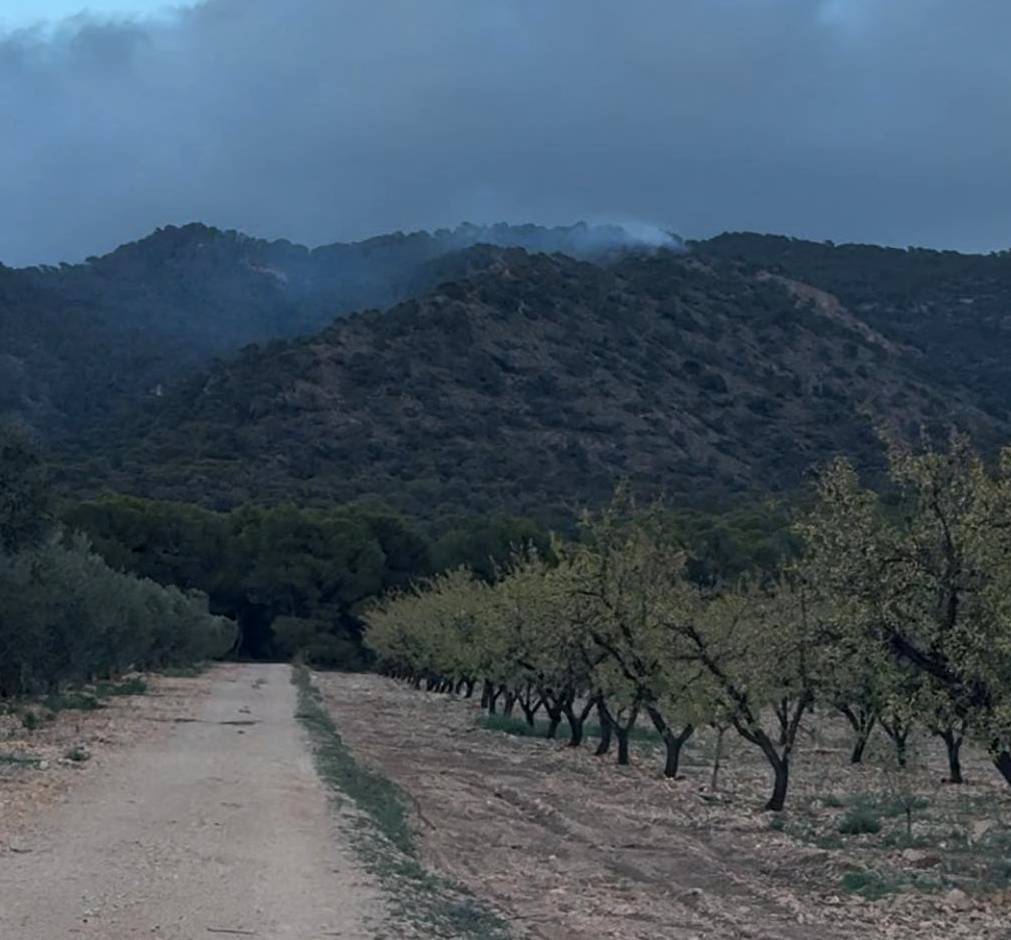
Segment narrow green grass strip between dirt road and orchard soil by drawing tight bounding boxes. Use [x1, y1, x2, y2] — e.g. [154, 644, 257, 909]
[291, 666, 510, 940]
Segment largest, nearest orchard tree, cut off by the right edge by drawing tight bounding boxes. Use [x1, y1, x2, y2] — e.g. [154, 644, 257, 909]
[801, 437, 1011, 784]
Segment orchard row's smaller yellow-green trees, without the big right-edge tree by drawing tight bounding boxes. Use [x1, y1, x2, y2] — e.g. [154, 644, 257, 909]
[365, 489, 830, 810]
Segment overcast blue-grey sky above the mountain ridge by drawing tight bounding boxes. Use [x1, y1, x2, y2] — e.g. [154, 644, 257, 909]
[0, 0, 1011, 265]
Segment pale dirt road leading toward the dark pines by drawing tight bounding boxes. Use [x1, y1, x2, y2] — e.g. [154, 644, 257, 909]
[0, 665, 383, 940]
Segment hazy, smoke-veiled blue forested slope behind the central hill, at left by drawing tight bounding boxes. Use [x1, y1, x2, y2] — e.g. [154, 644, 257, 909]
[0, 224, 655, 439]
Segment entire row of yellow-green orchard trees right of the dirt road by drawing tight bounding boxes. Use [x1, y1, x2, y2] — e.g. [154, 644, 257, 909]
[366, 439, 1011, 811]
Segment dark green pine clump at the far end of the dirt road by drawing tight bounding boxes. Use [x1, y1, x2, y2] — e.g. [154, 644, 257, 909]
[64, 495, 431, 668]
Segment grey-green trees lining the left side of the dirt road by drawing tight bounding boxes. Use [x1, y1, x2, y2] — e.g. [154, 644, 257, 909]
[0, 429, 235, 698]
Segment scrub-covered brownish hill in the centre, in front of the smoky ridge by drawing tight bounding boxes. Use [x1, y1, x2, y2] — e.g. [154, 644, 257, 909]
[70, 248, 1006, 523]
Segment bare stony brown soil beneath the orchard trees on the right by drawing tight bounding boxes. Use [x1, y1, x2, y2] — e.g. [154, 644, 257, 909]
[317, 675, 1011, 940]
